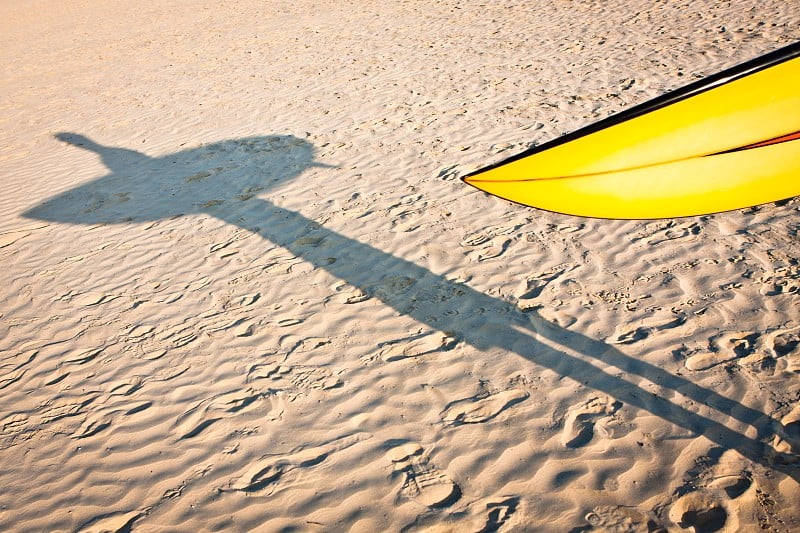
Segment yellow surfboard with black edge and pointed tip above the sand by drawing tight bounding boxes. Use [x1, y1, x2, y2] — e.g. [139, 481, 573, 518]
[463, 43, 800, 219]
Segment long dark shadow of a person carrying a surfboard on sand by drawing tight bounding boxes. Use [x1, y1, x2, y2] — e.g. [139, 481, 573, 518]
[24, 133, 797, 479]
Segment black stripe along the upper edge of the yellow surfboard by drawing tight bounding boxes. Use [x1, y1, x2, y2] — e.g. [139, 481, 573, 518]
[461, 42, 800, 179]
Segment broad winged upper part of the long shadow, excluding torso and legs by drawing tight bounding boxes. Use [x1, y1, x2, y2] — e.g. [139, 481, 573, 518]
[23, 132, 326, 224]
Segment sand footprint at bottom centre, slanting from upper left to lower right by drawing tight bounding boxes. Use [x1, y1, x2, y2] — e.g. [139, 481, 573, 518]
[387, 442, 461, 508]
